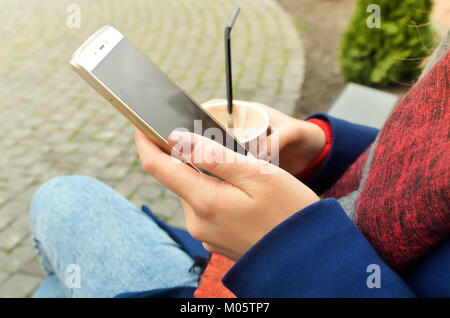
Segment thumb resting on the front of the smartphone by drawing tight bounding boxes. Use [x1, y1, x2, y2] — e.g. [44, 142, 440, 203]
[169, 131, 262, 188]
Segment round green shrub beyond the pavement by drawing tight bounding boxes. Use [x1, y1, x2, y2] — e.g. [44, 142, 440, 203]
[339, 0, 434, 85]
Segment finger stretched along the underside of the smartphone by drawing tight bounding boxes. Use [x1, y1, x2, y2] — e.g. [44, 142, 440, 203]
[135, 129, 225, 203]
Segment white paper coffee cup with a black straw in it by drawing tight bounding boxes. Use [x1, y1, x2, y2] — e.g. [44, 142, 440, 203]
[202, 101, 269, 147]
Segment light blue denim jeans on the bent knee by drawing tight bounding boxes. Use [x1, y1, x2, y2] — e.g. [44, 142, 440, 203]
[30, 176, 199, 297]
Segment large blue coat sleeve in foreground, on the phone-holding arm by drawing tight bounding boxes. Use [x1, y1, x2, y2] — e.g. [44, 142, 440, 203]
[223, 199, 415, 297]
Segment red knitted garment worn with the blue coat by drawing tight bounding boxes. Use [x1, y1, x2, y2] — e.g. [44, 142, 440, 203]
[194, 52, 450, 297]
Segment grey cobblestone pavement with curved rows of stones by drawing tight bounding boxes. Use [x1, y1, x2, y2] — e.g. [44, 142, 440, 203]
[0, 0, 303, 297]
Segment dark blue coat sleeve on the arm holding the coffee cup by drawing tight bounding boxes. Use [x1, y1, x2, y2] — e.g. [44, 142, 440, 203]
[303, 113, 378, 194]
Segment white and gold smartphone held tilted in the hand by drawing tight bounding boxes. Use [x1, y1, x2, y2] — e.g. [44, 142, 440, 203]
[70, 26, 248, 170]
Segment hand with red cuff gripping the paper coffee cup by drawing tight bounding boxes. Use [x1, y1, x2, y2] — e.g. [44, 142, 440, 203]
[205, 99, 326, 176]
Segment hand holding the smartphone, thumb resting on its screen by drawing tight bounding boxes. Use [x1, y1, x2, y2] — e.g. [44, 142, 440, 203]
[135, 130, 319, 260]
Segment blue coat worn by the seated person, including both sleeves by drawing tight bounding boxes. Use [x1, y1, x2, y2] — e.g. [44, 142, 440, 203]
[118, 114, 450, 297]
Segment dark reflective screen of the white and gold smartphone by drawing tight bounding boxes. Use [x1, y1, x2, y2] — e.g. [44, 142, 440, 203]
[92, 37, 247, 154]
